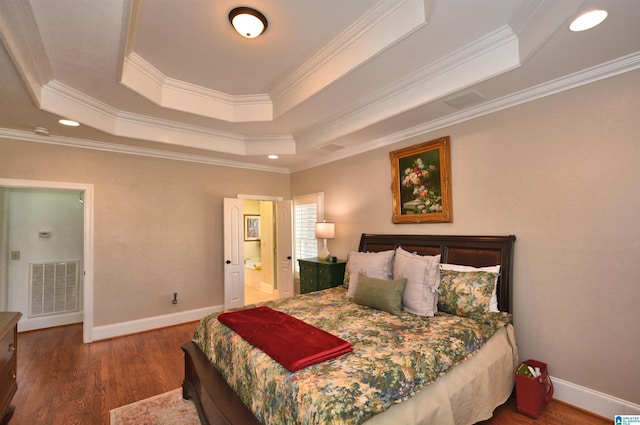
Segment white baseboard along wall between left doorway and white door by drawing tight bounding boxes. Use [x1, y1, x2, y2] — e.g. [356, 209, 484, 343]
[92, 305, 224, 341]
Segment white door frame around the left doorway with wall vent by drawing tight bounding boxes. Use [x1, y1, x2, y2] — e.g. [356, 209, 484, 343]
[0, 178, 93, 343]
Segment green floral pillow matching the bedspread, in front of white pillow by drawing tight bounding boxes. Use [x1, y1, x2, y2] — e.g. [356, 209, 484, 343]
[438, 270, 497, 317]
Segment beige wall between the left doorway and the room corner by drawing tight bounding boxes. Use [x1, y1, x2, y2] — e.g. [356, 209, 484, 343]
[0, 142, 289, 326]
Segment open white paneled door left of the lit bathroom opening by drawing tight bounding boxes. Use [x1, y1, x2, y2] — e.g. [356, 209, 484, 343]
[223, 198, 244, 310]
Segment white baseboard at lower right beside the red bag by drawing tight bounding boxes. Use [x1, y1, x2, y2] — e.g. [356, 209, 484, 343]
[551, 376, 640, 421]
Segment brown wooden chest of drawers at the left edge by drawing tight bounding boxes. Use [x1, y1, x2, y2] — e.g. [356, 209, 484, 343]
[0, 312, 22, 424]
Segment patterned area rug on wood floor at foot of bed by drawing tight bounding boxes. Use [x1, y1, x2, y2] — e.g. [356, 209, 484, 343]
[109, 388, 200, 425]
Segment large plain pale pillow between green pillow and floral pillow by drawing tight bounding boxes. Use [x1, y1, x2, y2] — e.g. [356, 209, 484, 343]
[393, 247, 440, 316]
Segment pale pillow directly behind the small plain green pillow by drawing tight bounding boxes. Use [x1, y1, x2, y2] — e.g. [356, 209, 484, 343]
[345, 250, 394, 298]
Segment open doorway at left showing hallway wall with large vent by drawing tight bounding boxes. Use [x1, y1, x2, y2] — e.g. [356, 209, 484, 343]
[1, 187, 84, 331]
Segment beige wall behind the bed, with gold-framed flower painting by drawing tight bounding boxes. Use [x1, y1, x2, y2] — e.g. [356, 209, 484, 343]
[291, 71, 640, 403]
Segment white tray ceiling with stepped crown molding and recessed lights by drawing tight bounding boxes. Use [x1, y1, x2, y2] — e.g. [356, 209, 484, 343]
[0, 0, 640, 172]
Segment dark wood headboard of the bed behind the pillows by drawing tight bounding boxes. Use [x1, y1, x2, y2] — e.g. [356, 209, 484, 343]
[358, 233, 516, 313]
